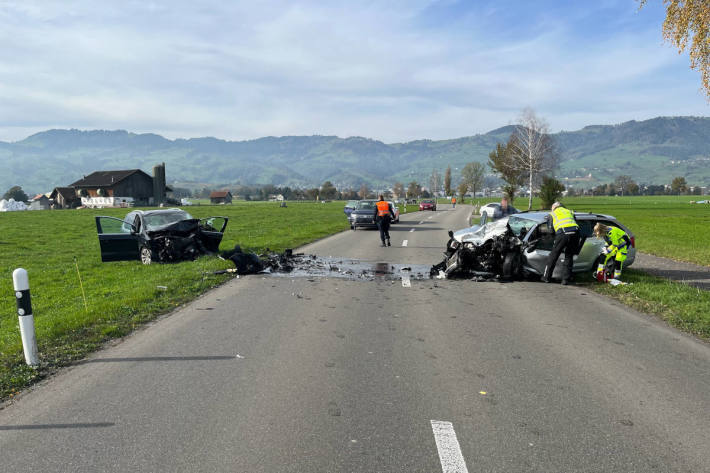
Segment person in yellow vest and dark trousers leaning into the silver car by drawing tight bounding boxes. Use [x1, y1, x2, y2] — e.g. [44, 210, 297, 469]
[541, 202, 579, 285]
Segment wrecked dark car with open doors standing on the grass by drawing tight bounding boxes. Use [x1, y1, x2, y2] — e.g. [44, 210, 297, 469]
[96, 208, 229, 264]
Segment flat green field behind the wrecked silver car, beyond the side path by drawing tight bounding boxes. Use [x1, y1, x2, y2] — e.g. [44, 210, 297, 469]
[466, 195, 710, 266]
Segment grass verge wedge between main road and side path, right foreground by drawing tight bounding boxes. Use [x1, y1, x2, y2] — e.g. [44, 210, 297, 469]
[585, 269, 710, 340]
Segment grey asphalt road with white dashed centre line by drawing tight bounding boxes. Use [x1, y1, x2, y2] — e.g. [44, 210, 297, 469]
[0, 206, 710, 473]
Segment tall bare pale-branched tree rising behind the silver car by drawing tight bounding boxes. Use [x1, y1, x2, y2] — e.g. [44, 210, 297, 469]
[507, 108, 559, 210]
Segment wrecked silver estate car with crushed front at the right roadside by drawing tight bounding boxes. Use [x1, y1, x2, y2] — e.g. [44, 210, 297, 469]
[432, 212, 636, 280]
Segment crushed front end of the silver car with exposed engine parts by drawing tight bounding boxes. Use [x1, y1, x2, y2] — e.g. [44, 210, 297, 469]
[430, 227, 523, 281]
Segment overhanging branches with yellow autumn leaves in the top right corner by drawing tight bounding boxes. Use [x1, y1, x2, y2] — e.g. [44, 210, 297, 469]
[639, 0, 710, 100]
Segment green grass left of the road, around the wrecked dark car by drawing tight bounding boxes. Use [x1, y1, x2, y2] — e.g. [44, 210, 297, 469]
[0, 202, 348, 399]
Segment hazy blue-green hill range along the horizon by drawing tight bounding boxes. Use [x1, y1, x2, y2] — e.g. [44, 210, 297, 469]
[0, 117, 710, 193]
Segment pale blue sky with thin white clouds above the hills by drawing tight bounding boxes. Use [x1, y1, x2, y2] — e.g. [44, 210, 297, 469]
[0, 0, 710, 143]
